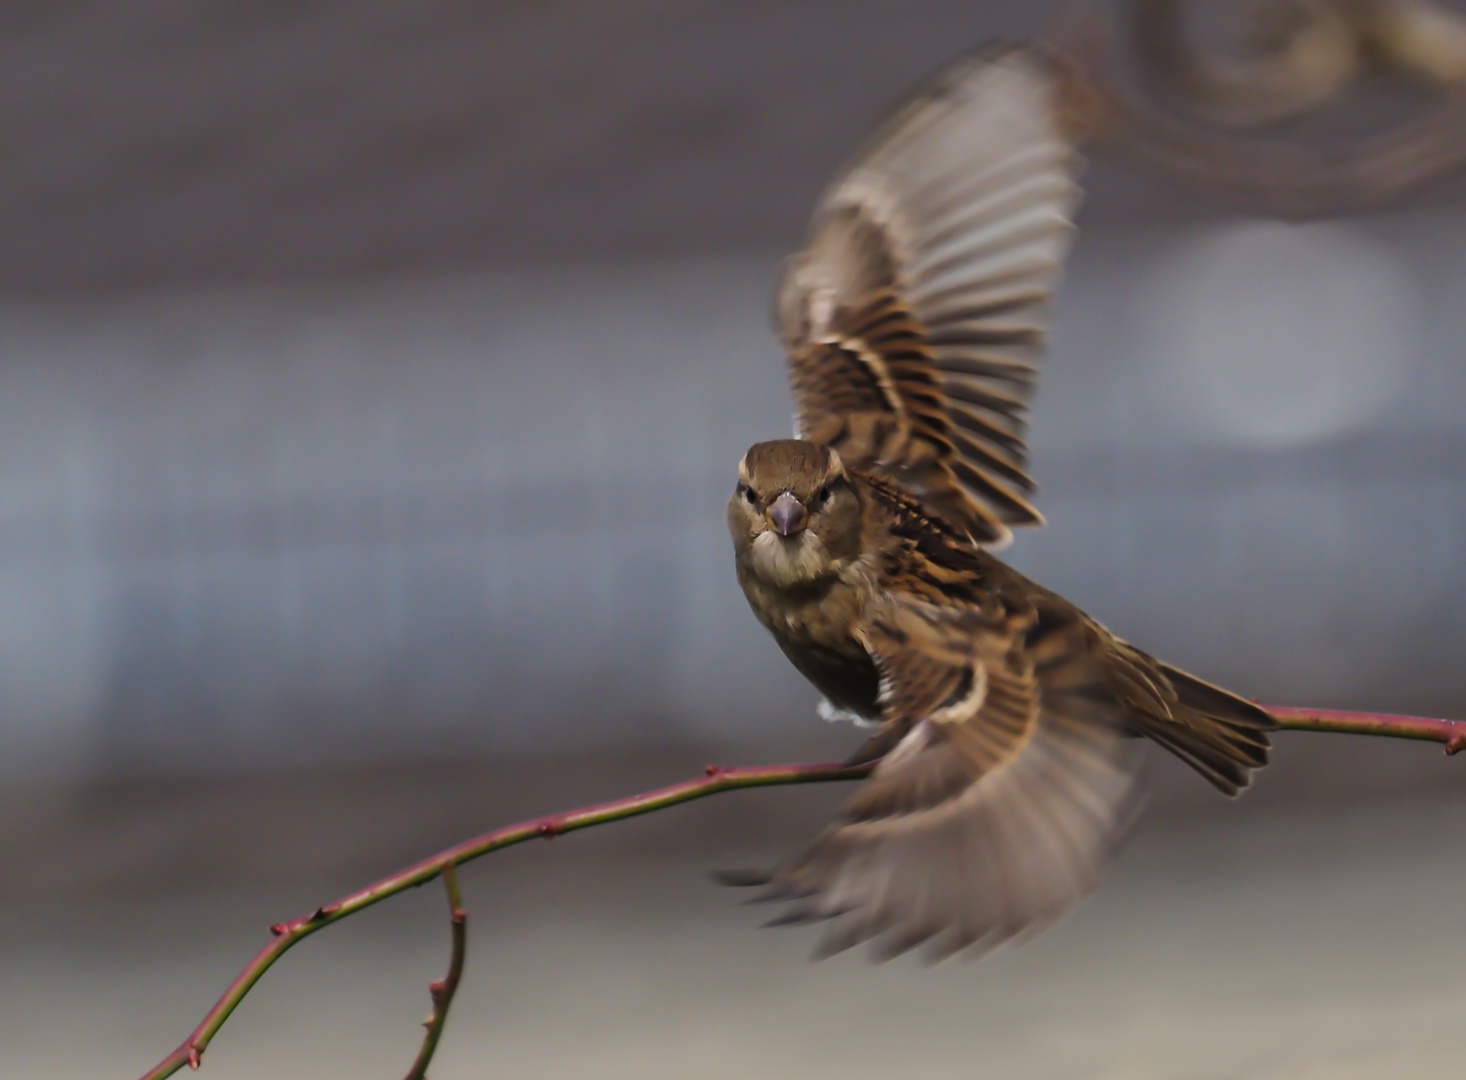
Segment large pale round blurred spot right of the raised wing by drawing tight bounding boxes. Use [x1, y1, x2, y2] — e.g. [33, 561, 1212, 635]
[1139, 221, 1421, 448]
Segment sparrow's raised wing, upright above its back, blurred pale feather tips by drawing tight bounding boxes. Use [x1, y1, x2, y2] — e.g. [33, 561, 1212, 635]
[777, 48, 1080, 545]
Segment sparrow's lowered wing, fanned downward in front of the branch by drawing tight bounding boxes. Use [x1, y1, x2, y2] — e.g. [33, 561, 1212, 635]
[744, 599, 1139, 958]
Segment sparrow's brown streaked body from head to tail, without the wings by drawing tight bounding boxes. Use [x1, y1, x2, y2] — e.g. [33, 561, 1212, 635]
[729, 440, 1272, 794]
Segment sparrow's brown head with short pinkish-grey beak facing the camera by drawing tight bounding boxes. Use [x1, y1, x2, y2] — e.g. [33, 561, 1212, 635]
[727, 438, 861, 589]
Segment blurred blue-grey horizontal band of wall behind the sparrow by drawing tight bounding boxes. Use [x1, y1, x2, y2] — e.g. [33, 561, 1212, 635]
[0, 206, 1466, 778]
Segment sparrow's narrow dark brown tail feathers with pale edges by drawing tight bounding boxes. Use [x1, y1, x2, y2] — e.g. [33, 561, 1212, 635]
[1119, 648, 1278, 796]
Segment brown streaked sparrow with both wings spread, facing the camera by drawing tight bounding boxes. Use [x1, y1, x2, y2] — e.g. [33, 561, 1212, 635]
[726, 42, 1277, 960]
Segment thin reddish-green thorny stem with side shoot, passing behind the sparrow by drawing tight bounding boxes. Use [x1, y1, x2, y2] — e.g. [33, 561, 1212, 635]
[131, 705, 1466, 1080]
